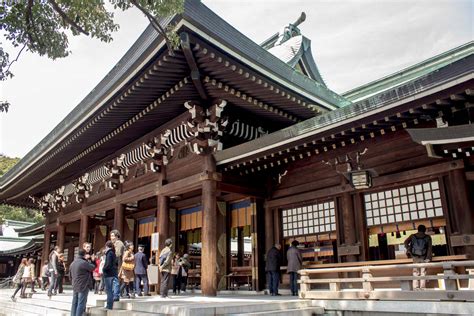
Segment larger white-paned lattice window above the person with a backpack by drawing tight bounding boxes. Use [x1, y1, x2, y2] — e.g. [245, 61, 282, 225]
[364, 181, 443, 226]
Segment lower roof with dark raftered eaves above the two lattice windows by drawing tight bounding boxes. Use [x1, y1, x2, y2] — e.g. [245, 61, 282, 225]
[215, 50, 474, 173]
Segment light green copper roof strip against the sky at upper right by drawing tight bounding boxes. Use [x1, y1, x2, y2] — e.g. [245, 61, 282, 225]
[342, 41, 474, 102]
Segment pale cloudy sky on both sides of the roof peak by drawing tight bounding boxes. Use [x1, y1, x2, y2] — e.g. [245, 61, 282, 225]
[0, 0, 474, 158]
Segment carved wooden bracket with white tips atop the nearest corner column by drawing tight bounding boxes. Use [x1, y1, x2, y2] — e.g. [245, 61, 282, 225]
[184, 100, 229, 155]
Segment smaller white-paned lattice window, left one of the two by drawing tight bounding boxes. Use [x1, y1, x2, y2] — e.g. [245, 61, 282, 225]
[282, 201, 336, 237]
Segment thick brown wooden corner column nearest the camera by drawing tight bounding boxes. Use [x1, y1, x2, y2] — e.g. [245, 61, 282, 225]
[201, 155, 217, 296]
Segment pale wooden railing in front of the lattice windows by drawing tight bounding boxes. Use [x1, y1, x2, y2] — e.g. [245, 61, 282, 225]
[299, 260, 474, 301]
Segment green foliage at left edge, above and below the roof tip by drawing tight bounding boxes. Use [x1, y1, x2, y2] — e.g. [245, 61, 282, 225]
[0, 154, 43, 224]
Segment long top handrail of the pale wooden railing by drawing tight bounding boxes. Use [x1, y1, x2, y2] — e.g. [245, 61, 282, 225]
[298, 260, 474, 275]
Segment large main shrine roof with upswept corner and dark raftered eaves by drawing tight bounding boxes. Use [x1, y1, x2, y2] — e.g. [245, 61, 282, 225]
[0, 1, 350, 207]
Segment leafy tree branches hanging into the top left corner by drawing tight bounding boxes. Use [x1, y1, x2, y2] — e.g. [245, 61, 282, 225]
[0, 0, 184, 112]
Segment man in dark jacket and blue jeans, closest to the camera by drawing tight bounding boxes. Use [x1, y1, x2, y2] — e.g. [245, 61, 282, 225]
[69, 249, 95, 316]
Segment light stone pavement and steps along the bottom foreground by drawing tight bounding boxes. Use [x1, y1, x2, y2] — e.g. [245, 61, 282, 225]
[0, 288, 324, 316]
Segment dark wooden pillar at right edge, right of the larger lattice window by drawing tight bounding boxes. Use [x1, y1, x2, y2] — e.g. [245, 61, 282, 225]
[448, 169, 474, 258]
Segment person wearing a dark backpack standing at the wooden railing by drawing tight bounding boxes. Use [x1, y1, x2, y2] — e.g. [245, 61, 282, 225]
[405, 225, 433, 290]
